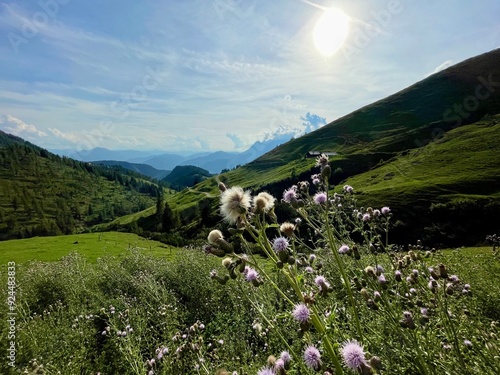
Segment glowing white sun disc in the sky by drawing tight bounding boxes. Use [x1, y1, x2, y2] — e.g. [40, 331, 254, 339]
[313, 8, 350, 56]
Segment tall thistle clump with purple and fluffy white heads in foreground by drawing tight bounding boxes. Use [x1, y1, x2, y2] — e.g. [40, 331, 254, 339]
[205, 155, 500, 375]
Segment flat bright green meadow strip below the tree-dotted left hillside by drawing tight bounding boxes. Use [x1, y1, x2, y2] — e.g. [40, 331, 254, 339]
[0, 232, 180, 264]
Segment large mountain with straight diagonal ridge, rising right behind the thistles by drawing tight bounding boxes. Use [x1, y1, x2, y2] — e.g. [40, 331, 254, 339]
[167, 49, 500, 246]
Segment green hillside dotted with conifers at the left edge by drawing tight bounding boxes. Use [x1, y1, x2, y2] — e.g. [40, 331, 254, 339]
[0, 132, 158, 240]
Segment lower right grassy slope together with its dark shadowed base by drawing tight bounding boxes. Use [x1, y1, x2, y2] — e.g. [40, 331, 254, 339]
[347, 115, 500, 246]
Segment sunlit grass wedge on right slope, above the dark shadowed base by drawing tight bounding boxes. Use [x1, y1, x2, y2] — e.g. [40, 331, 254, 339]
[347, 117, 500, 203]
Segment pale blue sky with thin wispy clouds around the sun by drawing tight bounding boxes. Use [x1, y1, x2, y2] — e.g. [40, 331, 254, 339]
[0, 0, 500, 153]
